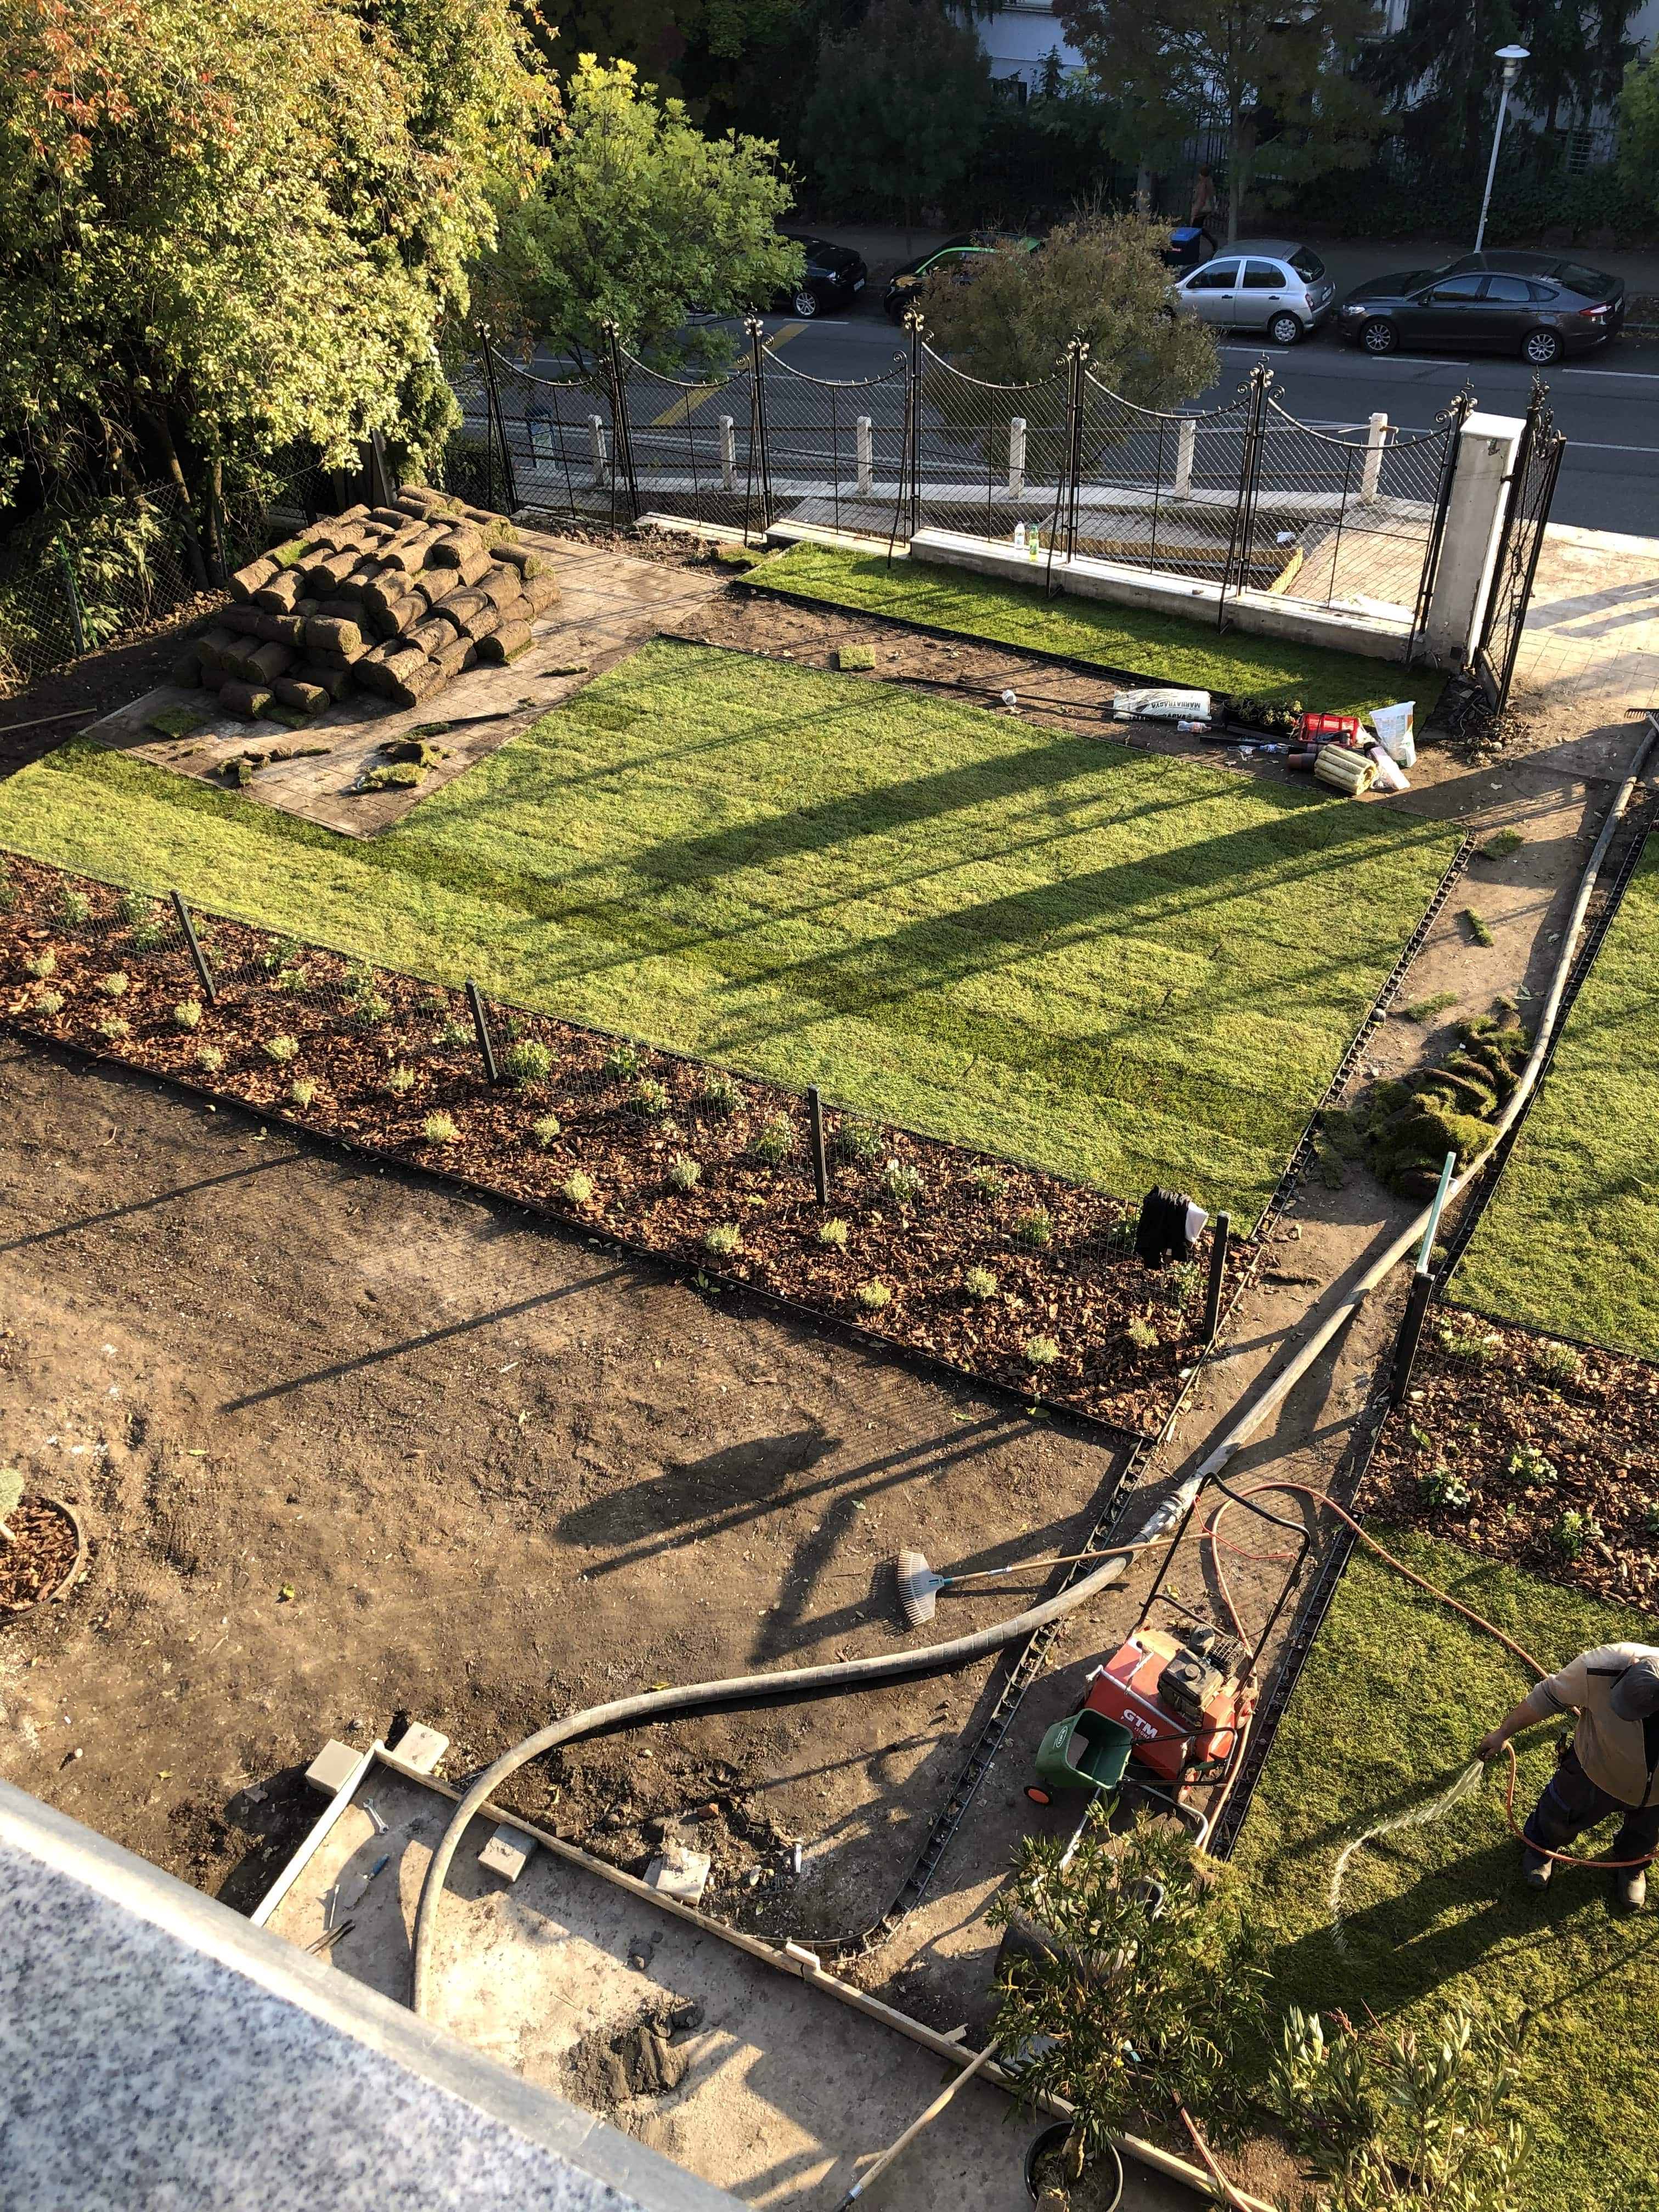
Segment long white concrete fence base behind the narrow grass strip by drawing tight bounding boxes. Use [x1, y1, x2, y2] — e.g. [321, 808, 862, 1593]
[909, 531, 1411, 662]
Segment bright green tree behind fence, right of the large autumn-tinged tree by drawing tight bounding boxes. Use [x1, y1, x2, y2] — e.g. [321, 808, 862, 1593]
[493, 53, 803, 365]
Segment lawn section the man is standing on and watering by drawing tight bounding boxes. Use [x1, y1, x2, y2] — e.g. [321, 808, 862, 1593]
[1234, 1531, 1659, 2212]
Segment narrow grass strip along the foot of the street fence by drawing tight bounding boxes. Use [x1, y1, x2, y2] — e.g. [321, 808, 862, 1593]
[757, 542, 1447, 725]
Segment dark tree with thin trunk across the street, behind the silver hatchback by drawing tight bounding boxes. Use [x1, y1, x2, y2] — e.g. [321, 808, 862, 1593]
[1055, 0, 1380, 241]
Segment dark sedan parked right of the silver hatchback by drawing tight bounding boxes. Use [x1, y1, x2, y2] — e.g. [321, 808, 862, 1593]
[1336, 252, 1623, 369]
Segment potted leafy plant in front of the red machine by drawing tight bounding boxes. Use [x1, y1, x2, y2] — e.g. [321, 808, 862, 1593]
[991, 1805, 1263, 2212]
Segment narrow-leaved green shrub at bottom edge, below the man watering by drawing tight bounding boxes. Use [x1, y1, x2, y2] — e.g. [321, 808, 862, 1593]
[1263, 2006, 1526, 2212]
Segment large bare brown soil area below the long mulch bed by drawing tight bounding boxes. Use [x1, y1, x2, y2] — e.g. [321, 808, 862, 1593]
[0, 1042, 1128, 1936]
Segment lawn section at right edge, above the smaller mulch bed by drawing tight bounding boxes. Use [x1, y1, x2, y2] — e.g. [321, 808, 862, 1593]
[1451, 840, 1659, 1358]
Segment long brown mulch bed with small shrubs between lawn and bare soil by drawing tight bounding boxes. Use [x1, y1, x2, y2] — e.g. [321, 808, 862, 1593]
[0, 858, 1254, 1436]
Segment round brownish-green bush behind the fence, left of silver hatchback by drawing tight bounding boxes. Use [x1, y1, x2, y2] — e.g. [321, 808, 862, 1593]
[922, 215, 1217, 407]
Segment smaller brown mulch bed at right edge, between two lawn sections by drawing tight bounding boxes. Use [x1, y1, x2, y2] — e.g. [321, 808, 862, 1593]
[1361, 1307, 1659, 1606]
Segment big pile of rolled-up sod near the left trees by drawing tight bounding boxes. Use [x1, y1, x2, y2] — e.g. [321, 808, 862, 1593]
[172, 484, 560, 719]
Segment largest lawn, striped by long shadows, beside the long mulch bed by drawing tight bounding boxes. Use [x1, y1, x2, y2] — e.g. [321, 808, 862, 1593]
[0, 641, 1455, 1217]
